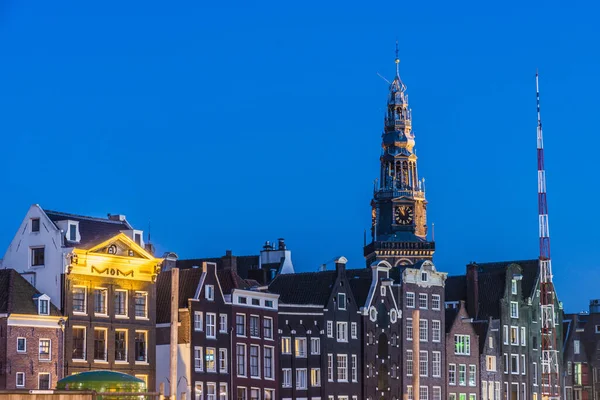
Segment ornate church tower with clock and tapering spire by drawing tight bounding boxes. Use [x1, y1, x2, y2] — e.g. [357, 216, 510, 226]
[364, 50, 435, 266]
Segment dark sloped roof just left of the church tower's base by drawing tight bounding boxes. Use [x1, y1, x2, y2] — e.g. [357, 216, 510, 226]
[269, 271, 337, 306]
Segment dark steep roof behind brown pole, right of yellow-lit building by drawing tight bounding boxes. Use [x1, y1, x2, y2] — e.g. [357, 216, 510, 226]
[156, 268, 202, 324]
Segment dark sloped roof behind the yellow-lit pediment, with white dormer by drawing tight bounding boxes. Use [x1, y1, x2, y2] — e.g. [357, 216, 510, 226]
[44, 210, 133, 249]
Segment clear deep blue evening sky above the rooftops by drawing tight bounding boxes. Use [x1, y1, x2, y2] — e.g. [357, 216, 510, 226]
[0, 0, 600, 312]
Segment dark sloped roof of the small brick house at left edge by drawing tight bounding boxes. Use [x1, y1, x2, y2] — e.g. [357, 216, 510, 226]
[0, 269, 62, 316]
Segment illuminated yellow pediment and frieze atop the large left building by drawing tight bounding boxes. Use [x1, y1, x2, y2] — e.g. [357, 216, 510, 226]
[69, 233, 163, 281]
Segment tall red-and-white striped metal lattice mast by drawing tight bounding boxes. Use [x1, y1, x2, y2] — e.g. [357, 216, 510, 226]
[535, 71, 560, 400]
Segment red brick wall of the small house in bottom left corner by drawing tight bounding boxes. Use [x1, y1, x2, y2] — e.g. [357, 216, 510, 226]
[3, 326, 62, 389]
